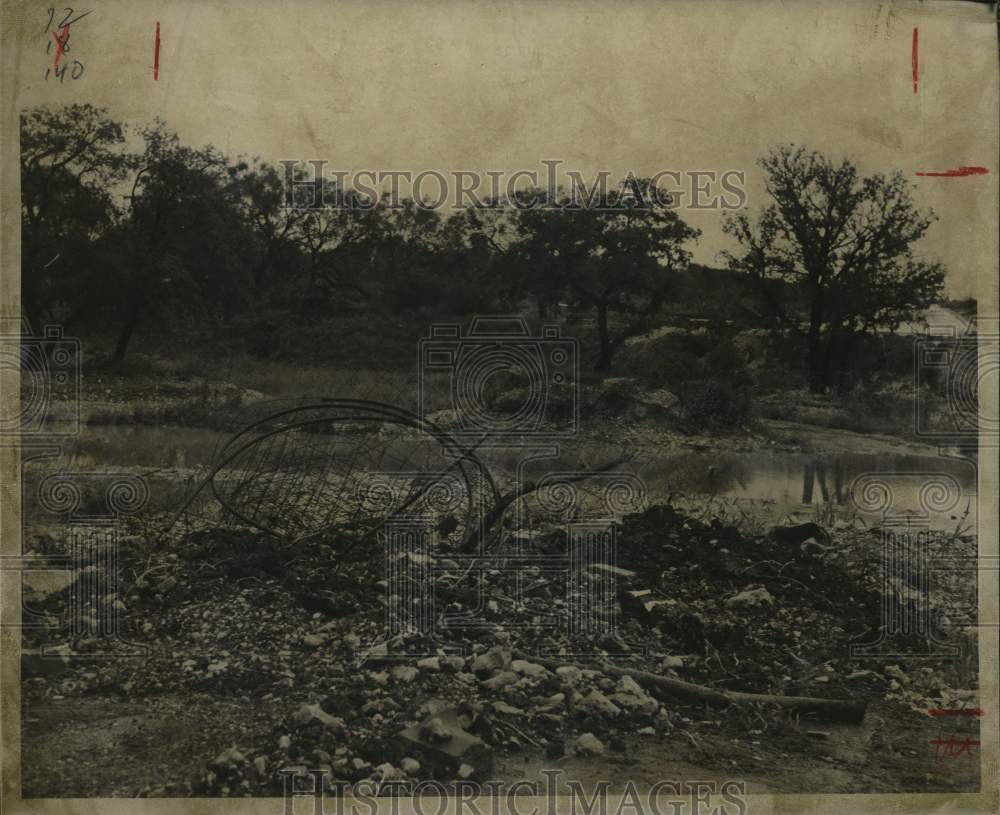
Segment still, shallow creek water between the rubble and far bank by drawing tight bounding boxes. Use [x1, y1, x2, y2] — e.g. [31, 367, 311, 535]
[29, 425, 976, 528]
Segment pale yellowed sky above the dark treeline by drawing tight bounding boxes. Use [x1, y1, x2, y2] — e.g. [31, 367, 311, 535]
[14, 0, 998, 300]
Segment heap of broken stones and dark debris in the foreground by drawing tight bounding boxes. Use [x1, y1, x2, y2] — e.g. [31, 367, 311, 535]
[19, 506, 980, 795]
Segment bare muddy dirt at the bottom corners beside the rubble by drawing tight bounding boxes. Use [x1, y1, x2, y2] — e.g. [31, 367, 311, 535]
[22, 695, 980, 797]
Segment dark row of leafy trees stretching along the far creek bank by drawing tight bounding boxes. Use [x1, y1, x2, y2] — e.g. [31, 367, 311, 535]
[21, 104, 944, 390]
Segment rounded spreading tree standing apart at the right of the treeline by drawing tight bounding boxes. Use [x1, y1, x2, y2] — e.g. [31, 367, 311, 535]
[724, 146, 944, 393]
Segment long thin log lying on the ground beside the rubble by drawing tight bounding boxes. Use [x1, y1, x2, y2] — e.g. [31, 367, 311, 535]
[515, 652, 867, 724]
